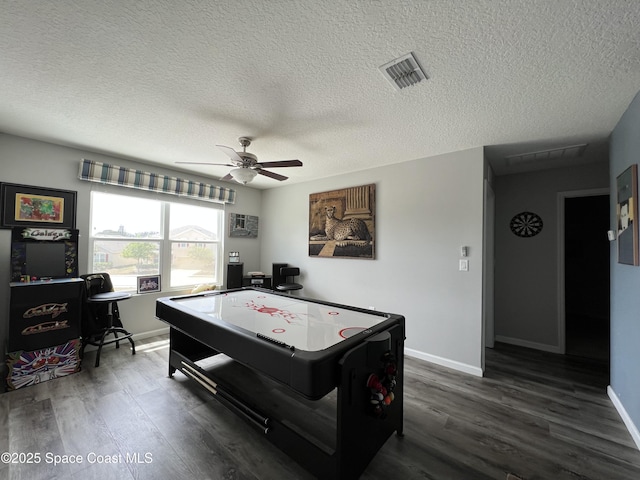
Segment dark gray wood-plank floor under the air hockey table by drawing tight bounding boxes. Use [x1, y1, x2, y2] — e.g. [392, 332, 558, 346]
[0, 337, 640, 480]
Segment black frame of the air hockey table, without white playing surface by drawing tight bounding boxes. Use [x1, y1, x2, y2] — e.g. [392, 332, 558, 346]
[156, 288, 405, 479]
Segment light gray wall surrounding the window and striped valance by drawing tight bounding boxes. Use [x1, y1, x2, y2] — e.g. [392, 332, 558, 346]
[0, 134, 261, 354]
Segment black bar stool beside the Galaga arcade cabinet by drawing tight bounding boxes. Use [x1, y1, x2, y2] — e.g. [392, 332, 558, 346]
[80, 273, 136, 367]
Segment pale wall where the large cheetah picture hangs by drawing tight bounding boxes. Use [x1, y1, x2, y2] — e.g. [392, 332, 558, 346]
[260, 148, 484, 375]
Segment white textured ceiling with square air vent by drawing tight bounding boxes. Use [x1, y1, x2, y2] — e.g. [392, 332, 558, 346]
[0, 0, 640, 188]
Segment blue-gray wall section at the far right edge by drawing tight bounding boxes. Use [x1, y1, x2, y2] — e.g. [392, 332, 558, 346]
[610, 93, 640, 447]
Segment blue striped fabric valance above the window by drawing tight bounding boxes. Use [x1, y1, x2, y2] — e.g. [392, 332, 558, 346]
[79, 159, 236, 203]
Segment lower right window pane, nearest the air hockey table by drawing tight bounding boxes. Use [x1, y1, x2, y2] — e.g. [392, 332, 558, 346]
[171, 242, 218, 287]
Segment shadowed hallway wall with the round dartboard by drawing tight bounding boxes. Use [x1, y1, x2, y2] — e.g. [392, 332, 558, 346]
[494, 161, 609, 353]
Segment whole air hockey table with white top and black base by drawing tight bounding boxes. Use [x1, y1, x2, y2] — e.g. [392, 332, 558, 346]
[156, 287, 405, 479]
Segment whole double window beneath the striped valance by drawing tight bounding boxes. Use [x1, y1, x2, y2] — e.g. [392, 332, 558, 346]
[89, 192, 223, 291]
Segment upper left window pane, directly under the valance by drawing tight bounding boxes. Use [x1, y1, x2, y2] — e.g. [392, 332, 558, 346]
[91, 192, 162, 238]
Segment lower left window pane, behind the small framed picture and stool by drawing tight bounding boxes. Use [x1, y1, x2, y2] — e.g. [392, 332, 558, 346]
[91, 240, 160, 291]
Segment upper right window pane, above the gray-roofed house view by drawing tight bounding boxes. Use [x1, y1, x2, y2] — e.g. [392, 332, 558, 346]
[169, 203, 220, 242]
